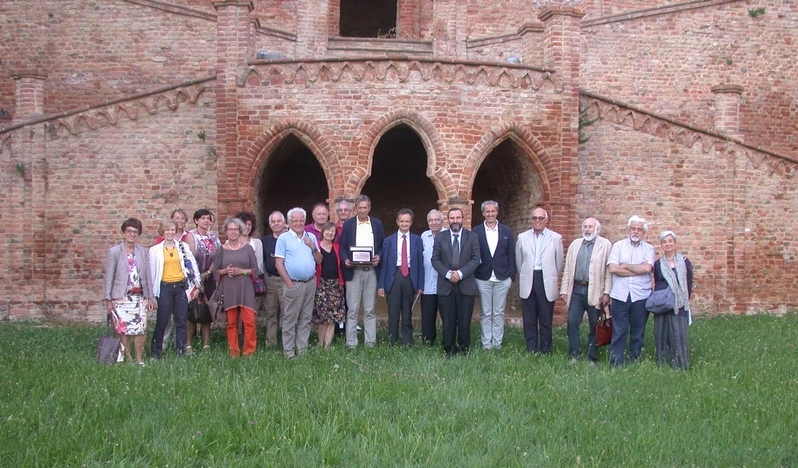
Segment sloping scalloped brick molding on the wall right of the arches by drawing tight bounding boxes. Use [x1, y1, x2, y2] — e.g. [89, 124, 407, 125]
[580, 90, 798, 179]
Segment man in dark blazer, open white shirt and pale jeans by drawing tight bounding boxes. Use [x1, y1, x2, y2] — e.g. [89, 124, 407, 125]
[473, 200, 517, 350]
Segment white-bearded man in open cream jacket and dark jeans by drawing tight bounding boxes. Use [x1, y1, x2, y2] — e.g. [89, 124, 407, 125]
[560, 218, 612, 365]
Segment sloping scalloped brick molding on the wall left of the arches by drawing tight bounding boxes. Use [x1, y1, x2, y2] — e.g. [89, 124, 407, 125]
[0, 76, 216, 139]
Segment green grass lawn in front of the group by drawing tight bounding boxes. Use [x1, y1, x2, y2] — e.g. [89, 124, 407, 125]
[0, 314, 798, 467]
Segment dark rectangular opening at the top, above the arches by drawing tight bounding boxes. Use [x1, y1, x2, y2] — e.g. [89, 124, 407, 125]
[339, 0, 397, 37]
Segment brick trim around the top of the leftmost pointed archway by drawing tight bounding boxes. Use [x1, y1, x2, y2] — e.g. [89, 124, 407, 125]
[245, 119, 344, 199]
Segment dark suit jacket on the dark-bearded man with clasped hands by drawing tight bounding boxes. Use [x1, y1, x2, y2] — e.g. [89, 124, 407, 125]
[432, 229, 480, 296]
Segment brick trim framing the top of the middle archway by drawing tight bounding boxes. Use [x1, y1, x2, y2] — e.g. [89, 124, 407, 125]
[352, 109, 457, 199]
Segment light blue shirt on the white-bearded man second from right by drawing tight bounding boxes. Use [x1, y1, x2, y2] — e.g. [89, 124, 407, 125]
[607, 238, 656, 302]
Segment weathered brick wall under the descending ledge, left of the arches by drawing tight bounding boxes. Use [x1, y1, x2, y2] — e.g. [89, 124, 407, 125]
[0, 82, 217, 318]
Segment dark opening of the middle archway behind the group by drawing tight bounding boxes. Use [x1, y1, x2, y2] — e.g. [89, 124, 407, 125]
[361, 125, 438, 236]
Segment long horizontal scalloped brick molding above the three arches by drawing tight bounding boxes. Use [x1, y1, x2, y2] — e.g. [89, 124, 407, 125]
[241, 57, 563, 93]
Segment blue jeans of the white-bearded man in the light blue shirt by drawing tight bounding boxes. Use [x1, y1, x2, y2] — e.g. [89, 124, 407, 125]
[610, 297, 648, 366]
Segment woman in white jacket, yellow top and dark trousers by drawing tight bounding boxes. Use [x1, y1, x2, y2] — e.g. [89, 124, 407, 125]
[150, 219, 200, 359]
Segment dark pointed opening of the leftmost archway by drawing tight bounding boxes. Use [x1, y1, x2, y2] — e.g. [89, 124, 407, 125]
[257, 135, 329, 235]
